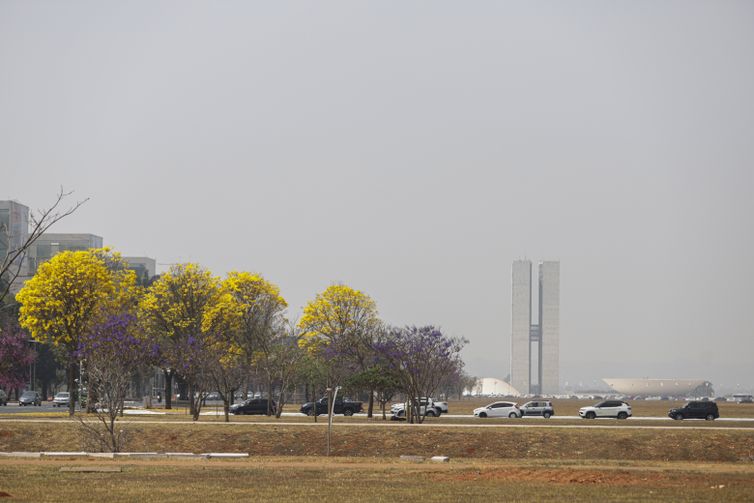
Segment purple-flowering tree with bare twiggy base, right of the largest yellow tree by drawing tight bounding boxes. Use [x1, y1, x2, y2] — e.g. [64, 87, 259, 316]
[76, 314, 153, 452]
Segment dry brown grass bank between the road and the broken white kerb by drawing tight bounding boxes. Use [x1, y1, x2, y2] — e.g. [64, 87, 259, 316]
[0, 421, 754, 462]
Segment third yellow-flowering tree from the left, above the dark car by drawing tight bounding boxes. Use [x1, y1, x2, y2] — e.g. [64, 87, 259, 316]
[203, 271, 288, 405]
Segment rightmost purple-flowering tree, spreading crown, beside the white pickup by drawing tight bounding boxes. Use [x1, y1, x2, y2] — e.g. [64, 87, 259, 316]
[375, 325, 467, 423]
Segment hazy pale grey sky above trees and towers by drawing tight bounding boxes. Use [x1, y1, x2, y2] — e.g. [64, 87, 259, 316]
[0, 0, 754, 390]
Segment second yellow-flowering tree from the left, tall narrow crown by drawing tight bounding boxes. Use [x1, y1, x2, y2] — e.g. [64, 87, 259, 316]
[139, 264, 220, 420]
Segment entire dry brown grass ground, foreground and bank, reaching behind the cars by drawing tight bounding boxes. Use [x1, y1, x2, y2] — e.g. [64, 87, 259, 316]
[0, 400, 754, 502]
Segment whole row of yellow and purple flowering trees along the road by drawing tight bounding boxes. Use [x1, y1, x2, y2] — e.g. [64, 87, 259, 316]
[0, 248, 468, 434]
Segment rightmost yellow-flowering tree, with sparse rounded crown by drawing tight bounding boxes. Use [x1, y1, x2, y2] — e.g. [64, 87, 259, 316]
[299, 285, 382, 417]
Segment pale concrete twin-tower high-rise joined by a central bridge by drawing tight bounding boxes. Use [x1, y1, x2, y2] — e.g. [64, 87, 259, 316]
[510, 260, 560, 395]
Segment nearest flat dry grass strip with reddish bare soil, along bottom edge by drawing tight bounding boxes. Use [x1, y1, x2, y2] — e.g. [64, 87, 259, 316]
[0, 457, 754, 503]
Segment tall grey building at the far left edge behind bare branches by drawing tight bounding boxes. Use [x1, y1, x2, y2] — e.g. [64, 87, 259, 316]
[0, 201, 34, 293]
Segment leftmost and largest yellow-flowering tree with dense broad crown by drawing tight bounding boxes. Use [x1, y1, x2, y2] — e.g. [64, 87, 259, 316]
[16, 248, 140, 415]
